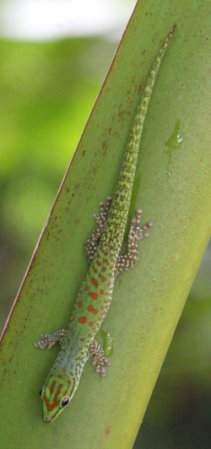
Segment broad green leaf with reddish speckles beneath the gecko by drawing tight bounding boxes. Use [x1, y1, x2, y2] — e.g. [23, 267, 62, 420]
[0, 0, 211, 449]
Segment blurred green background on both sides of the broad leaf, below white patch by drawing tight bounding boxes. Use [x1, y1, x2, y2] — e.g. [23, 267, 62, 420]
[0, 0, 211, 449]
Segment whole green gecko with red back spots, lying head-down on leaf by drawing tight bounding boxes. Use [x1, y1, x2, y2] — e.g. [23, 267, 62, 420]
[35, 25, 176, 422]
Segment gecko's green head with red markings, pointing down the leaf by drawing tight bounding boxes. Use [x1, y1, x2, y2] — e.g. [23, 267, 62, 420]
[41, 372, 76, 423]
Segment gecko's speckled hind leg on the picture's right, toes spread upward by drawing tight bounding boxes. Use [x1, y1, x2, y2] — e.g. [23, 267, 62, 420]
[115, 209, 152, 275]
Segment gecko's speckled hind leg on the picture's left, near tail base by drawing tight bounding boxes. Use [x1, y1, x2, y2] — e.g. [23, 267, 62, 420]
[85, 196, 112, 262]
